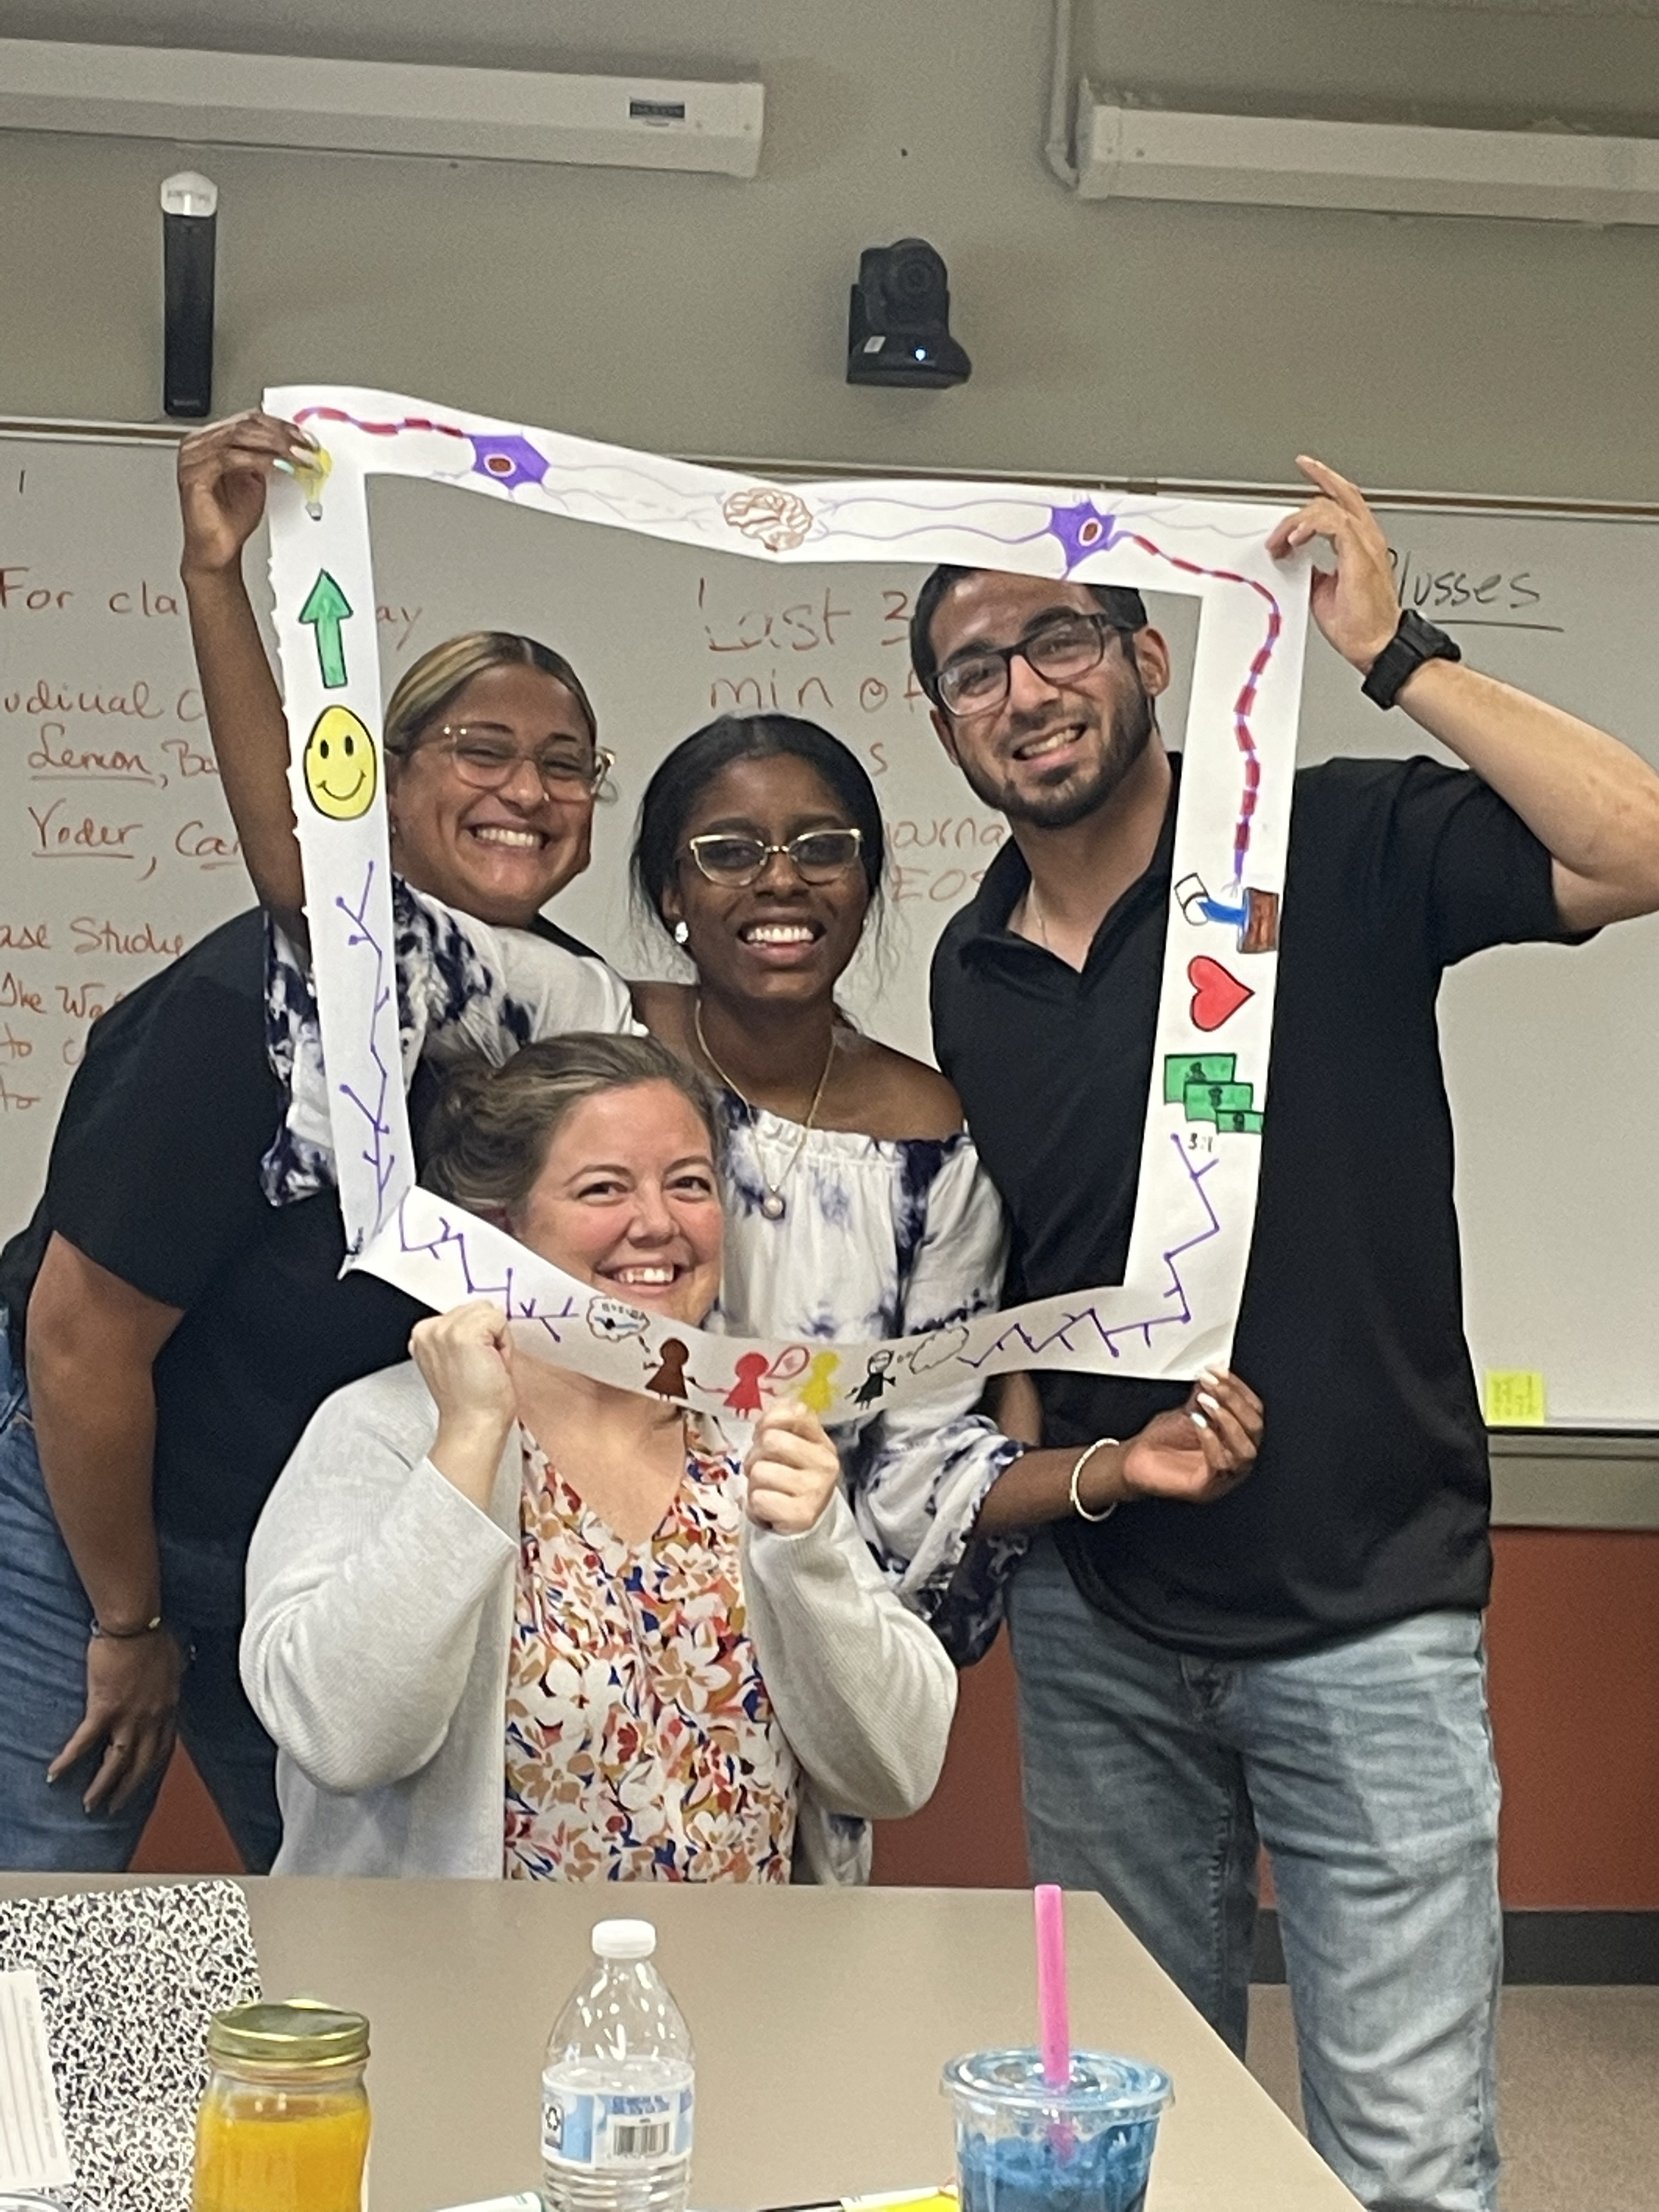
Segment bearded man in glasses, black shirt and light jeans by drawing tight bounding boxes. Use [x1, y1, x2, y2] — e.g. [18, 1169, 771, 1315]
[911, 462, 1659, 2212]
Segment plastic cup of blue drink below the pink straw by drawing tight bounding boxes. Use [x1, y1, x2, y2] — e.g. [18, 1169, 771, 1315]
[945, 2051, 1172, 2212]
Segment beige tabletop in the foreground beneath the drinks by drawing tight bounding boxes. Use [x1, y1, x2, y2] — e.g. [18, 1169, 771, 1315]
[0, 1874, 1354, 2212]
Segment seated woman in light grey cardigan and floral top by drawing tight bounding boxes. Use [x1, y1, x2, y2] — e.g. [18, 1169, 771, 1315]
[241, 1035, 956, 1882]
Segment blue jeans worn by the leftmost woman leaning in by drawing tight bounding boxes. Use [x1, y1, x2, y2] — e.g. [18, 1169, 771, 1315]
[0, 1314, 283, 1874]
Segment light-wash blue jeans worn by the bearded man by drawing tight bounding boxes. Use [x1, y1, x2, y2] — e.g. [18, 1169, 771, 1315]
[1009, 1537, 1502, 2212]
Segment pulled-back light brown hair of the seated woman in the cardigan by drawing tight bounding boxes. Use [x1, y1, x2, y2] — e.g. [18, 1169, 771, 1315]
[420, 1029, 721, 1215]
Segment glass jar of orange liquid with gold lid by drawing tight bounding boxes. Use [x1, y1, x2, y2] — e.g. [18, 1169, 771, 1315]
[190, 1997, 369, 2212]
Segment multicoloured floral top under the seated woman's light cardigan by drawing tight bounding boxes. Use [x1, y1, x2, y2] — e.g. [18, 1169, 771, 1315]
[504, 1434, 799, 1882]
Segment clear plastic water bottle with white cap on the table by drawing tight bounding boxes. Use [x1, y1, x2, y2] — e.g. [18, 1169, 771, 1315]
[542, 1920, 692, 2212]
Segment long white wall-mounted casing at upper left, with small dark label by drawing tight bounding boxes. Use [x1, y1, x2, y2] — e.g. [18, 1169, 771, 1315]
[0, 38, 765, 177]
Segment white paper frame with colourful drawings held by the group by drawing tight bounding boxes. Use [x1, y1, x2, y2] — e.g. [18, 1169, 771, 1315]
[266, 387, 1310, 1420]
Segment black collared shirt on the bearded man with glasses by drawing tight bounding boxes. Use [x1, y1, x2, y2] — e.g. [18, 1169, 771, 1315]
[934, 759, 1564, 1657]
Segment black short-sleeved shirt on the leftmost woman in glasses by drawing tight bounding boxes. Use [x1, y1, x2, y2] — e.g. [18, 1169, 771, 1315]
[0, 911, 584, 1546]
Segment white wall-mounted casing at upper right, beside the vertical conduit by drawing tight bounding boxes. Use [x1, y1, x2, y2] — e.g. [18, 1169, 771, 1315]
[1077, 84, 1659, 223]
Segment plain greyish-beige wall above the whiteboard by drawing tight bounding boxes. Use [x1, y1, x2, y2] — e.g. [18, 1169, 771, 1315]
[0, 0, 1659, 500]
